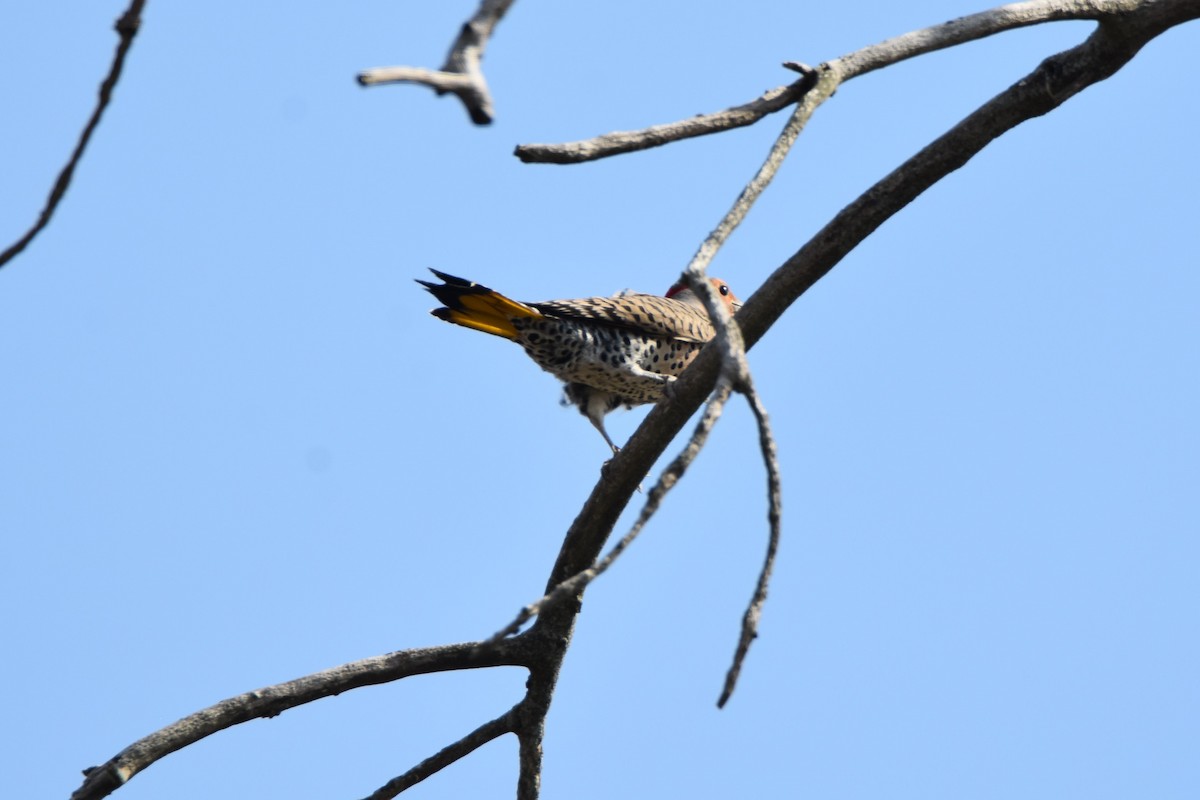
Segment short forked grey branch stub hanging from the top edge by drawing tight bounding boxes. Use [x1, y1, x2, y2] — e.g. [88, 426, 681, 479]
[358, 0, 515, 125]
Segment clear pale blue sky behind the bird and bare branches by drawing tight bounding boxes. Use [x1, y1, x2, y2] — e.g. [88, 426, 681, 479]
[0, 0, 1200, 800]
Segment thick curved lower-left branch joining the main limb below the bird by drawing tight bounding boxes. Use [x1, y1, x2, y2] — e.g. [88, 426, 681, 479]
[71, 639, 524, 800]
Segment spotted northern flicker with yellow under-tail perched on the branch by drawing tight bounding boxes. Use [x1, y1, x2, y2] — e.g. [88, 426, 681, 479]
[418, 270, 742, 453]
